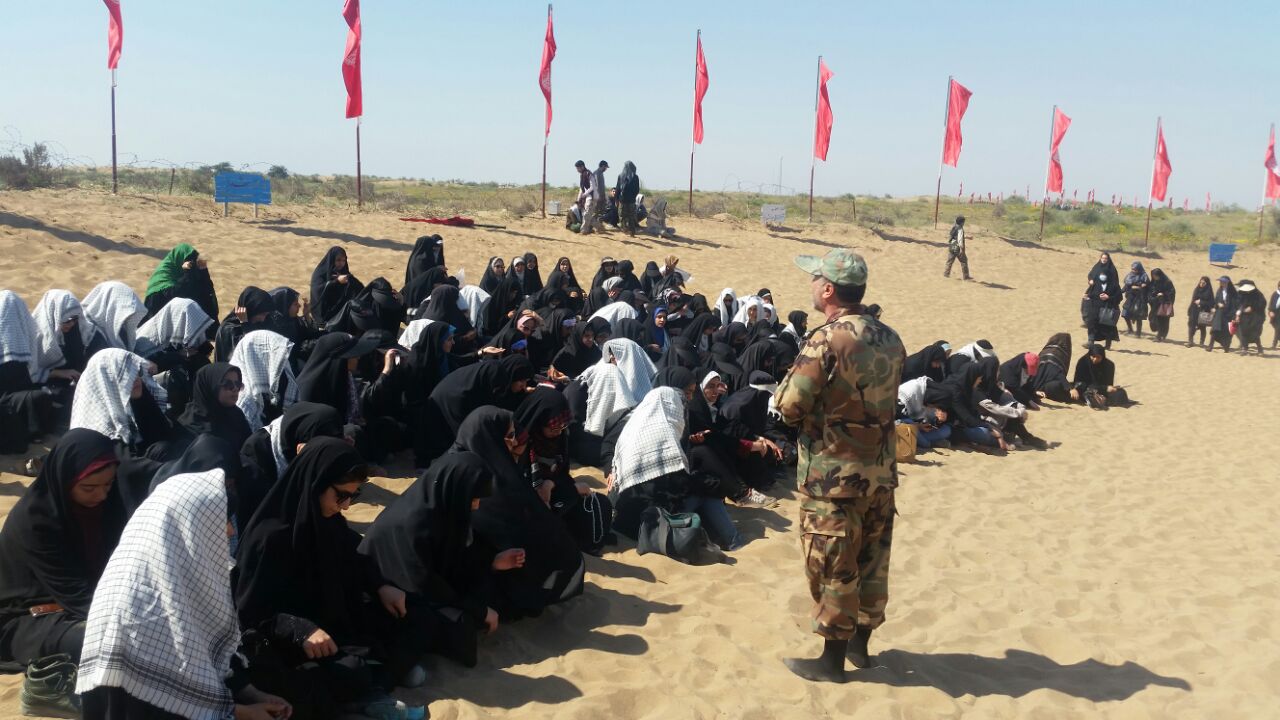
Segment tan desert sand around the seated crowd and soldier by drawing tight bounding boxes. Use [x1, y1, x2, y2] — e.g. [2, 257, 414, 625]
[0, 191, 1280, 720]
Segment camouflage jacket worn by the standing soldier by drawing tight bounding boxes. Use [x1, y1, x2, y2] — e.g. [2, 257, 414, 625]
[774, 308, 906, 500]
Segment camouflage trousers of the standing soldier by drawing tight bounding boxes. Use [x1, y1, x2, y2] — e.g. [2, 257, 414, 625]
[800, 487, 895, 641]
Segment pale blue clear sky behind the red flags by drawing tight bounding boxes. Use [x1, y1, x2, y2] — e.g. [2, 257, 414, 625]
[0, 0, 1280, 208]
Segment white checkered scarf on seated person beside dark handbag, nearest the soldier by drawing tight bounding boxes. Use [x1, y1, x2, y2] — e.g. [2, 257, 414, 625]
[613, 387, 689, 492]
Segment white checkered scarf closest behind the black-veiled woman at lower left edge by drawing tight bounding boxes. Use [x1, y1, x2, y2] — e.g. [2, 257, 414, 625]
[72, 347, 169, 443]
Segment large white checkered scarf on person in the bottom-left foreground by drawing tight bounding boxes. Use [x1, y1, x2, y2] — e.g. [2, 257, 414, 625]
[76, 470, 241, 720]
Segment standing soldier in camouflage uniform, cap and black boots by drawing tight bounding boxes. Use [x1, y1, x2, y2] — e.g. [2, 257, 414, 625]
[774, 250, 906, 682]
